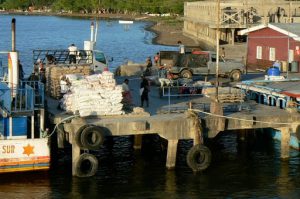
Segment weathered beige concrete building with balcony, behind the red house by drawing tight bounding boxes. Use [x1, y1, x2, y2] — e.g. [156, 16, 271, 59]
[183, 0, 300, 48]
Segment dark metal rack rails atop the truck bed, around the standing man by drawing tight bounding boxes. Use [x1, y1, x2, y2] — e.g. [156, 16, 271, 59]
[33, 50, 93, 64]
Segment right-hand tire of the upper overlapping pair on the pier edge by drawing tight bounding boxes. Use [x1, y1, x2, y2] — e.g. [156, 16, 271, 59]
[80, 126, 104, 150]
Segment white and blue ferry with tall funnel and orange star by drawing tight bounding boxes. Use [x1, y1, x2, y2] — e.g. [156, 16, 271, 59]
[0, 19, 50, 173]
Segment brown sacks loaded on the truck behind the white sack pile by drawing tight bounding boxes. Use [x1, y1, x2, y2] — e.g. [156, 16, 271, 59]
[46, 65, 91, 99]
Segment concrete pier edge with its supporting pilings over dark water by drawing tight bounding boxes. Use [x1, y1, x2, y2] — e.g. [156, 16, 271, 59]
[47, 91, 300, 176]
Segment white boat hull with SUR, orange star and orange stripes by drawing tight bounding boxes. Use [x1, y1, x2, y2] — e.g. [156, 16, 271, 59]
[0, 138, 50, 173]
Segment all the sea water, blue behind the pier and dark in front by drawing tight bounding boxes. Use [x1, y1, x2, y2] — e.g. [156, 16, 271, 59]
[0, 15, 300, 199]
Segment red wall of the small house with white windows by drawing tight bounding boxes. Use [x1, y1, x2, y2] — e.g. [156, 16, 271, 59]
[247, 28, 300, 69]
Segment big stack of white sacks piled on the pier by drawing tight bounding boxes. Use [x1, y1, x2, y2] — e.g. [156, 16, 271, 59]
[61, 71, 124, 117]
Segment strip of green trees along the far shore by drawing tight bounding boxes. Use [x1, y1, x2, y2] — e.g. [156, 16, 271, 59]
[0, 0, 199, 14]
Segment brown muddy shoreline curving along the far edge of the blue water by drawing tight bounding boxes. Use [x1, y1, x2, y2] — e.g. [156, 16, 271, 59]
[4, 12, 201, 48]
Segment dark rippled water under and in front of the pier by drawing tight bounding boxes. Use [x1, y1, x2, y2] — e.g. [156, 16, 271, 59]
[0, 132, 300, 199]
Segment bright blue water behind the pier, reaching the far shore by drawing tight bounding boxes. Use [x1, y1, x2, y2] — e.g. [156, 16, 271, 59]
[0, 15, 175, 74]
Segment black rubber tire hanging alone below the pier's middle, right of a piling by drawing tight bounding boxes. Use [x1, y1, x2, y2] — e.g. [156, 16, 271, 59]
[186, 144, 211, 172]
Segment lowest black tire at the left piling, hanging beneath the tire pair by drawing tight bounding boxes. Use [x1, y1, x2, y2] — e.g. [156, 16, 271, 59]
[75, 153, 98, 178]
